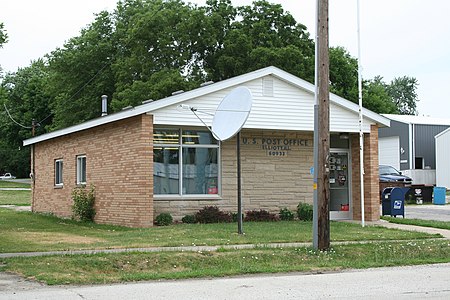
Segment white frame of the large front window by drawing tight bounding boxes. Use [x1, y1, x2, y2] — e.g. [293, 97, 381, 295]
[153, 126, 222, 200]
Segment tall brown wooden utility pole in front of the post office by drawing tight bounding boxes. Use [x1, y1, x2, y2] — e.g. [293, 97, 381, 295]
[317, 0, 330, 250]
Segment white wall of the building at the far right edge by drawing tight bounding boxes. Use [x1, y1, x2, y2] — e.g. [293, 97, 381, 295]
[436, 129, 450, 188]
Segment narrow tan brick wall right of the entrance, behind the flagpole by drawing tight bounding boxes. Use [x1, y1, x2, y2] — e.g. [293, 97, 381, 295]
[351, 125, 380, 221]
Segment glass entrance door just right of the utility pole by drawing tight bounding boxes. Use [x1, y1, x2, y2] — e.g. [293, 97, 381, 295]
[329, 149, 352, 220]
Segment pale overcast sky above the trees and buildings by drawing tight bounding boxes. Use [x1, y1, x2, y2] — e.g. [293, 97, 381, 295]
[0, 0, 450, 118]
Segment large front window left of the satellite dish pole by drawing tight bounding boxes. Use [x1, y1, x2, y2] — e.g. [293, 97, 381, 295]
[153, 129, 220, 196]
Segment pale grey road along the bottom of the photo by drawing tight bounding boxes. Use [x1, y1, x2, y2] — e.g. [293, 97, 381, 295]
[0, 263, 450, 300]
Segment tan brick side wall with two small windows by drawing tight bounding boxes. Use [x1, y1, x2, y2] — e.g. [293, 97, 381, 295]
[32, 115, 153, 227]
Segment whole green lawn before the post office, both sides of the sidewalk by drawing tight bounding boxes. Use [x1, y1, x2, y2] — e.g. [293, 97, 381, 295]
[0, 208, 450, 284]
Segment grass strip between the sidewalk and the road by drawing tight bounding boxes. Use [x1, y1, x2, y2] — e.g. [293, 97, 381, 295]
[0, 240, 450, 284]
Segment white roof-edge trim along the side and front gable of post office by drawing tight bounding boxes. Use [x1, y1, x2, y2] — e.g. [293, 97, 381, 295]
[23, 67, 390, 146]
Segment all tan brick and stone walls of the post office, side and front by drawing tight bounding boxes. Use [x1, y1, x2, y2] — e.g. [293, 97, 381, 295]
[32, 115, 379, 227]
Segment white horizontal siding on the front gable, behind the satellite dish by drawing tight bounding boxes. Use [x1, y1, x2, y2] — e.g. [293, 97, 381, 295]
[155, 75, 374, 132]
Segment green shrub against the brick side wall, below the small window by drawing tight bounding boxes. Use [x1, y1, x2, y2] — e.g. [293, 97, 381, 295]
[72, 185, 95, 222]
